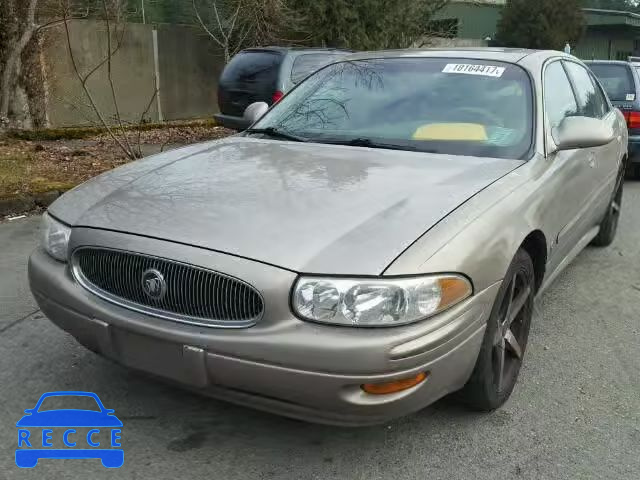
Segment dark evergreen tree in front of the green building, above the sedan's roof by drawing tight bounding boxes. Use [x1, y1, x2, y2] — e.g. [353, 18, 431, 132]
[497, 0, 585, 50]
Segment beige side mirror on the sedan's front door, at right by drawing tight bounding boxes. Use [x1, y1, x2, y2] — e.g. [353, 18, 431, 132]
[551, 117, 614, 151]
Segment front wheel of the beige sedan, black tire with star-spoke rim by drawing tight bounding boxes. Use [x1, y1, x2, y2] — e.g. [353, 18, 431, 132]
[458, 249, 535, 412]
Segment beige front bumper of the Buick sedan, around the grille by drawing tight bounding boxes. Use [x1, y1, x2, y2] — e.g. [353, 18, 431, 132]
[29, 231, 499, 425]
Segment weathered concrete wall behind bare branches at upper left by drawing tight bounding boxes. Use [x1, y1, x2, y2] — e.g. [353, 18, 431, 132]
[42, 20, 223, 127]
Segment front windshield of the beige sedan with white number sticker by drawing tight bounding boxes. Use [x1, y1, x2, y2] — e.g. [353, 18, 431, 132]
[254, 58, 533, 159]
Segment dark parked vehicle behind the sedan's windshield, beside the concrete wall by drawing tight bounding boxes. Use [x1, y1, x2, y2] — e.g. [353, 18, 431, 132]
[214, 47, 350, 130]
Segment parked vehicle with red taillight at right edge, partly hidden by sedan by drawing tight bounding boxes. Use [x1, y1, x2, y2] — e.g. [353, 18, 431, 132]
[586, 60, 640, 179]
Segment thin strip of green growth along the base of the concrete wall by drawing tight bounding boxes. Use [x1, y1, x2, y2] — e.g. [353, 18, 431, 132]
[7, 119, 216, 142]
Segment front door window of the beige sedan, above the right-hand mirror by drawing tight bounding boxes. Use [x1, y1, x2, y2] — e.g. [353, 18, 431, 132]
[544, 62, 578, 128]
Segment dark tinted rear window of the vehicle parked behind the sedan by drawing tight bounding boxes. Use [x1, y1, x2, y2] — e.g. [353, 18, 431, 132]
[220, 51, 282, 88]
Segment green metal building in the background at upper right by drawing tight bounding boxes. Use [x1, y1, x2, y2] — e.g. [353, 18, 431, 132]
[438, 0, 640, 60]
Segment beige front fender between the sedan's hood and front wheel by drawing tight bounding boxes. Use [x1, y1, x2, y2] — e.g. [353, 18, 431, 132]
[384, 157, 549, 291]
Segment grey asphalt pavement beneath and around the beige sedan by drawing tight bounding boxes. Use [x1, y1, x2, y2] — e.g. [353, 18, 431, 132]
[0, 182, 640, 480]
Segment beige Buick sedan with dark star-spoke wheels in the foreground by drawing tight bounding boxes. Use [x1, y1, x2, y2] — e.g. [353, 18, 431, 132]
[29, 49, 627, 425]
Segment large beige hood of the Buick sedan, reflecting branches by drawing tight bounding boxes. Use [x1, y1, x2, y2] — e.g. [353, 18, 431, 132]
[50, 137, 523, 275]
